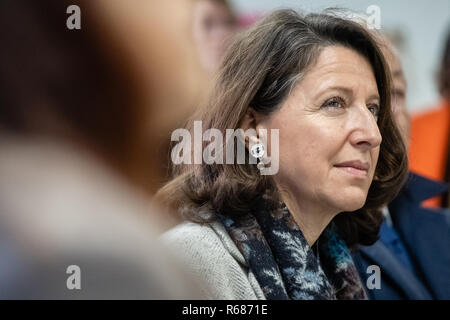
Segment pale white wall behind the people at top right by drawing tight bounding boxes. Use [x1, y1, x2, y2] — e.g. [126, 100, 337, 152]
[231, 0, 450, 112]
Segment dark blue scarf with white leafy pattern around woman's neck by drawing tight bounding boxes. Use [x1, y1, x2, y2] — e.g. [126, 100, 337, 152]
[220, 206, 367, 300]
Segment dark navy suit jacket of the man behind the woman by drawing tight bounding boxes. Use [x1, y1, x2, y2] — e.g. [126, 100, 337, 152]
[353, 173, 450, 300]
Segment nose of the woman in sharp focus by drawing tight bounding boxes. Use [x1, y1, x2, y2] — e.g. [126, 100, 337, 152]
[350, 105, 382, 149]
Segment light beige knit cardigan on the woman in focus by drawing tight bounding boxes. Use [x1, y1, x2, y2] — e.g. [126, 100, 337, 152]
[161, 222, 266, 300]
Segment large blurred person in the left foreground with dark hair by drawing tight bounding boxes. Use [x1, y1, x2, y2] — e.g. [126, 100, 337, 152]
[0, 0, 203, 298]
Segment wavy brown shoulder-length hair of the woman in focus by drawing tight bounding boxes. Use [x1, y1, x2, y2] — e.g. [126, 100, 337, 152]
[157, 10, 408, 246]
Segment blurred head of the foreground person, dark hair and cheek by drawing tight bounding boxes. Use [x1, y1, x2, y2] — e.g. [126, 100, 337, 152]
[0, 0, 201, 191]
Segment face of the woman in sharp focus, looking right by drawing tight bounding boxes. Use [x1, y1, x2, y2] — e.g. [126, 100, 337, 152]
[258, 46, 381, 213]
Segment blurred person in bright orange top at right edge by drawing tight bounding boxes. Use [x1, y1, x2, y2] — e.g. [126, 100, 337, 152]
[409, 32, 450, 207]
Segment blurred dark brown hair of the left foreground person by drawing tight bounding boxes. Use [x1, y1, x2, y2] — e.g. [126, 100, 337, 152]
[0, 0, 141, 175]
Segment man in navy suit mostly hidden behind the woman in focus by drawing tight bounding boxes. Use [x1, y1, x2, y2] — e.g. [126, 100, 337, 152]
[353, 35, 450, 300]
